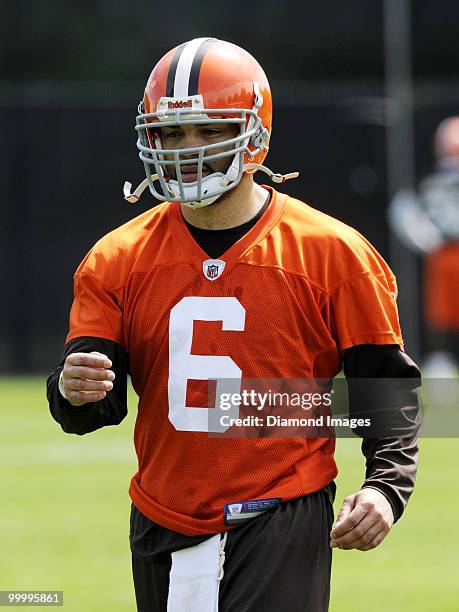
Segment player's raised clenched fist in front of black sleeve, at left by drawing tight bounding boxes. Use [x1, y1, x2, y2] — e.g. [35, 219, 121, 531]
[61, 351, 115, 406]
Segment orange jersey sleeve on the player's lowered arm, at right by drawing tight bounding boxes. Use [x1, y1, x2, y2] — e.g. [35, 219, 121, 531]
[330, 241, 403, 351]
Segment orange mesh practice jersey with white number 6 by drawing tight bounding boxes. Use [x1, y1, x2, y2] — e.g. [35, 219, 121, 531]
[67, 191, 402, 535]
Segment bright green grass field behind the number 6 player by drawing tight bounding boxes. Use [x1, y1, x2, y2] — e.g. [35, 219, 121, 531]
[0, 378, 459, 612]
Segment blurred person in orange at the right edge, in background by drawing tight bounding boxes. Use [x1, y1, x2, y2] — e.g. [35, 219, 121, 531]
[389, 116, 459, 377]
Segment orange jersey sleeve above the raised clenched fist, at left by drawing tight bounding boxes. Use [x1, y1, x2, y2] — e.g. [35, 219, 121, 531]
[66, 247, 124, 346]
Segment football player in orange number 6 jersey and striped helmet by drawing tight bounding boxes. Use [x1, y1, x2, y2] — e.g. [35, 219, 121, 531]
[48, 38, 419, 612]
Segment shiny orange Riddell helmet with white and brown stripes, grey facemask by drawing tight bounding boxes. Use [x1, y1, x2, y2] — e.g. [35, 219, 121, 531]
[124, 38, 298, 208]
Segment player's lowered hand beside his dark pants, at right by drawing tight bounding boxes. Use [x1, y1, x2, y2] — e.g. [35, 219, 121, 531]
[330, 488, 394, 550]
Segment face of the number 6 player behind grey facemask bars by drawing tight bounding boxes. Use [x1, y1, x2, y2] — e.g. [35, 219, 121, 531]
[161, 123, 239, 183]
